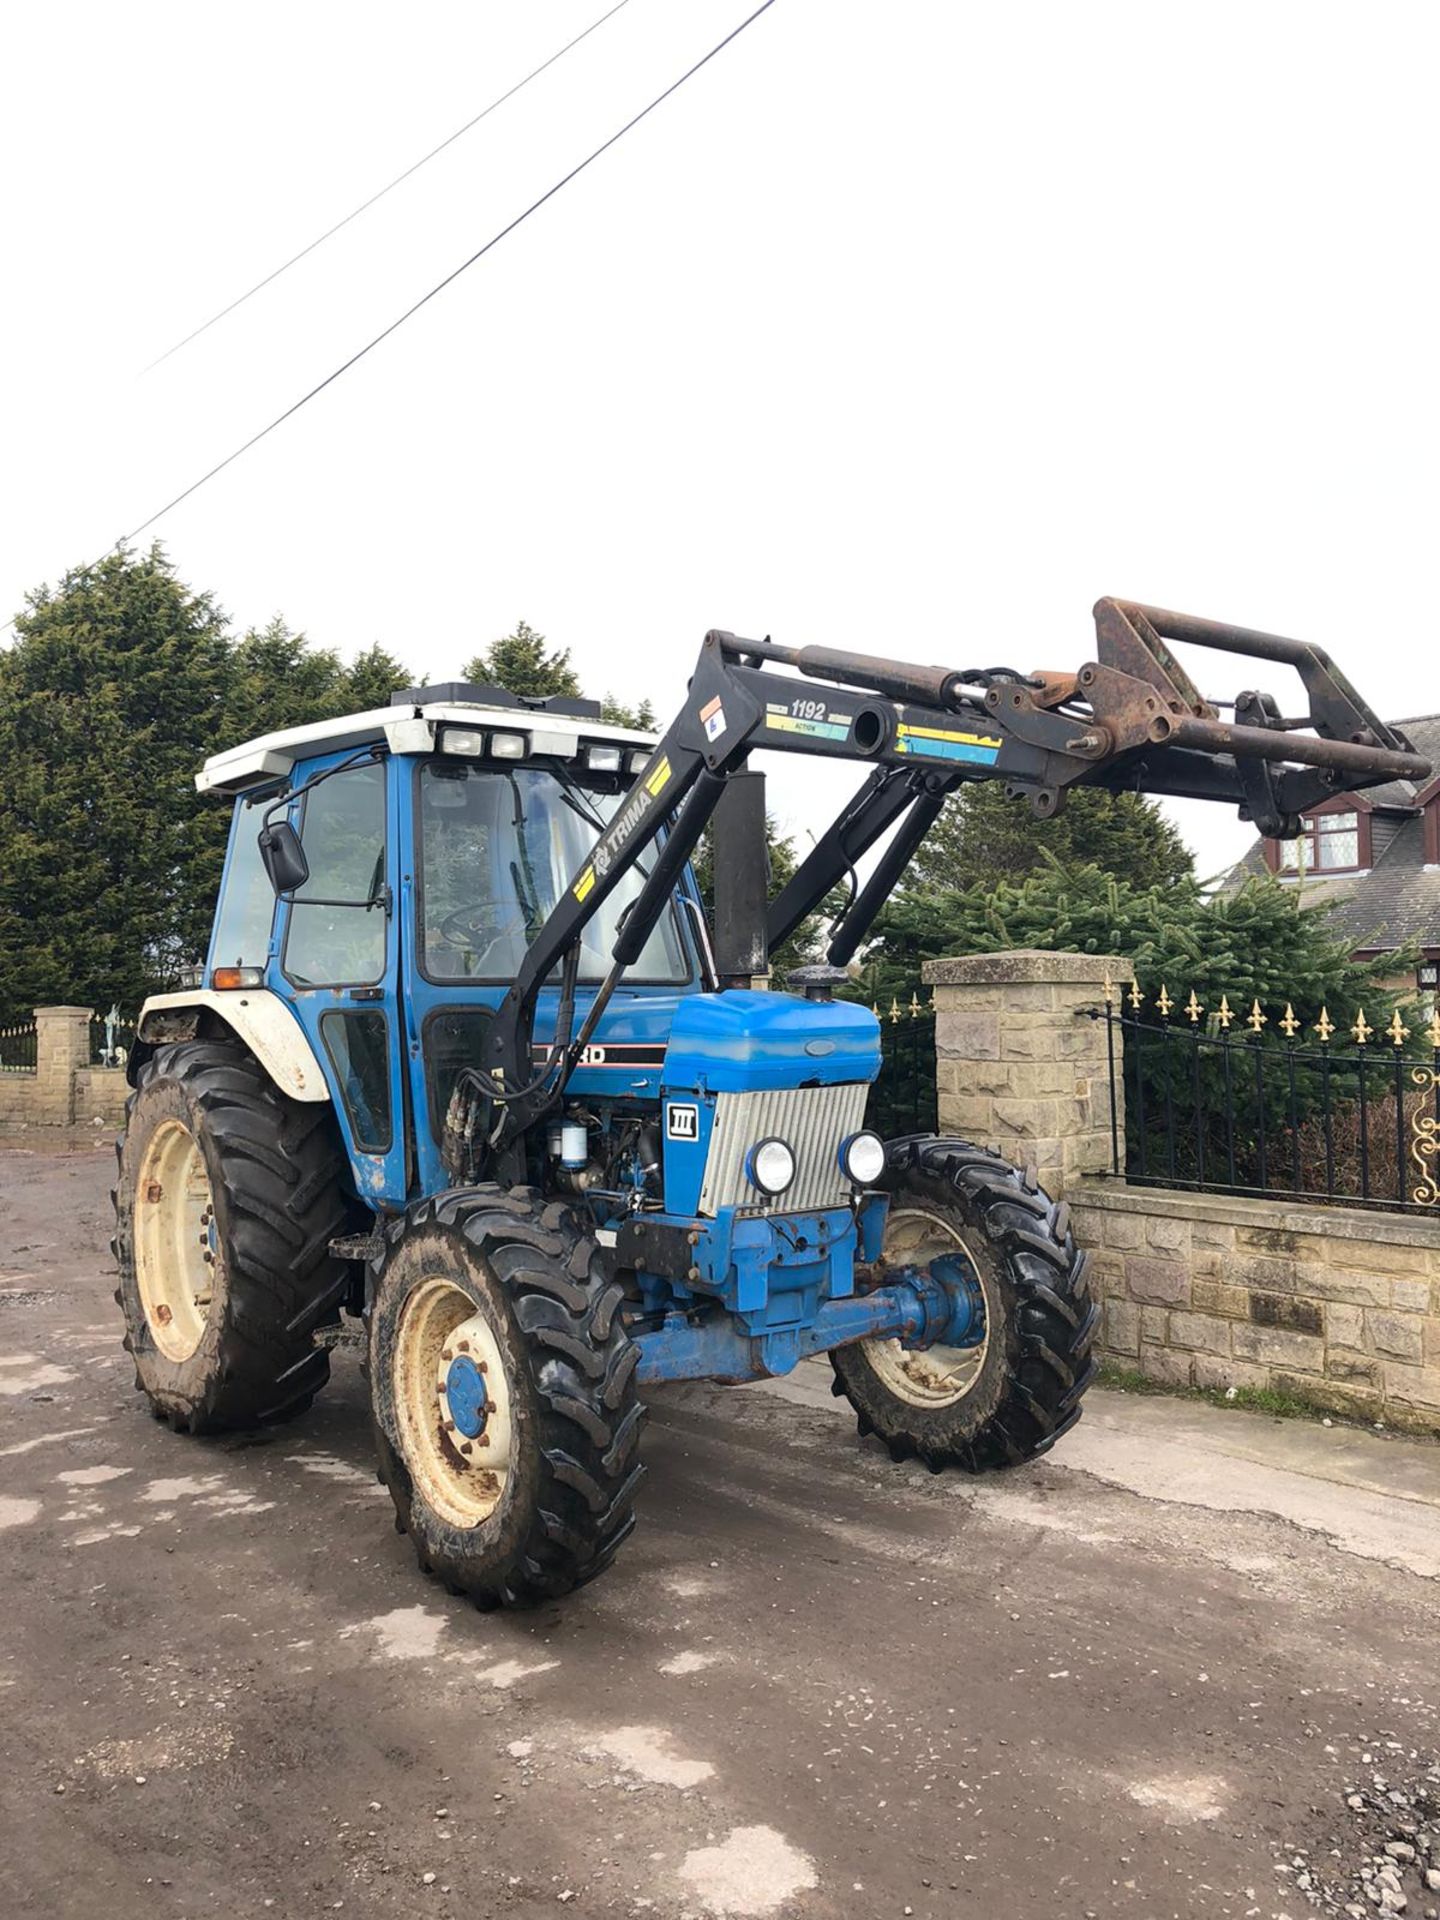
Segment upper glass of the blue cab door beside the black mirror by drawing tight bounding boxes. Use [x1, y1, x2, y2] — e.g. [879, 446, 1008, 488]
[284, 764, 386, 987]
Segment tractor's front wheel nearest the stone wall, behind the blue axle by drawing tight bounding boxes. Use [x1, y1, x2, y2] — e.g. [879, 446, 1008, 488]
[831, 1137, 1098, 1473]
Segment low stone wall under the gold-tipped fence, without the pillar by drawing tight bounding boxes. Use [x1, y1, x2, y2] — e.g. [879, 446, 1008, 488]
[1068, 1179, 1440, 1432]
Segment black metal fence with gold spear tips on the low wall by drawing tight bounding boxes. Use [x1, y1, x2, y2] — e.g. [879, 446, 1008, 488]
[1104, 987, 1440, 1217]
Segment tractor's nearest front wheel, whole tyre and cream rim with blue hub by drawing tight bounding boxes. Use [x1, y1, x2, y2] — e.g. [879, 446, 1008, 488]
[371, 1185, 645, 1607]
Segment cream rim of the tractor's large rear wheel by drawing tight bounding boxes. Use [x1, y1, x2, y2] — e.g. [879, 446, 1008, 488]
[134, 1119, 219, 1363]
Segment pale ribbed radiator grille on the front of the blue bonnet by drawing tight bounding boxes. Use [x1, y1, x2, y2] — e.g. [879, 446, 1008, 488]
[701, 1081, 870, 1213]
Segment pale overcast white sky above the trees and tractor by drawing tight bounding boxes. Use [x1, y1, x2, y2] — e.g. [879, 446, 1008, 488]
[0, 0, 1440, 870]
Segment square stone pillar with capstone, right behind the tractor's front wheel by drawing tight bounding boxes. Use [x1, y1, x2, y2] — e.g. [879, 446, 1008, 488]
[924, 950, 1135, 1196]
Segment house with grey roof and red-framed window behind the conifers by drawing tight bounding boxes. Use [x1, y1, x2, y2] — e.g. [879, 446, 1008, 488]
[1225, 714, 1440, 1002]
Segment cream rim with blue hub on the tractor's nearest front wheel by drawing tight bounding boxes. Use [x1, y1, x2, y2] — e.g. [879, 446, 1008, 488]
[394, 1277, 515, 1528]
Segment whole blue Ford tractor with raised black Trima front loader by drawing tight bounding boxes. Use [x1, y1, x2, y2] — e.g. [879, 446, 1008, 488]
[115, 601, 1428, 1605]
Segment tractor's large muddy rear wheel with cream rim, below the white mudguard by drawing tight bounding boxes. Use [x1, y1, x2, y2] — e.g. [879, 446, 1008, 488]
[111, 1041, 359, 1434]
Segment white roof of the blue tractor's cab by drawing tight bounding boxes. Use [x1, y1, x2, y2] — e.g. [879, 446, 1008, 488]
[196, 682, 657, 793]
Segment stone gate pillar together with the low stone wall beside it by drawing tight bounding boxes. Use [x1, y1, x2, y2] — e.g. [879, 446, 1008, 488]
[925, 952, 1440, 1432]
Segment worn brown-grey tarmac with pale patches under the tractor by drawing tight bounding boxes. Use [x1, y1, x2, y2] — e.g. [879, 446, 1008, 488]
[0, 1135, 1440, 1920]
